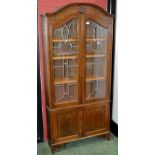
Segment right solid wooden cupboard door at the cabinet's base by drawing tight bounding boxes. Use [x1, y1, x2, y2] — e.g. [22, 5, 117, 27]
[84, 105, 109, 136]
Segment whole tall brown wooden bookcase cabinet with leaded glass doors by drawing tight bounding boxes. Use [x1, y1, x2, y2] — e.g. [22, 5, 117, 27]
[42, 3, 113, 151]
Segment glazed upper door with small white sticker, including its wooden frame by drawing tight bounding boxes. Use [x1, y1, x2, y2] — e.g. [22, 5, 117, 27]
[83, 17, 112, 103]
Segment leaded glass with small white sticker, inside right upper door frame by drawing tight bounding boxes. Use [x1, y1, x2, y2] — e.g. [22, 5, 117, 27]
[86, 19, 108, 100]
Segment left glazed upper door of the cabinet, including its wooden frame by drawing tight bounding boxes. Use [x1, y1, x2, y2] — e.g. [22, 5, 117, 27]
[49, 16, 81, 107]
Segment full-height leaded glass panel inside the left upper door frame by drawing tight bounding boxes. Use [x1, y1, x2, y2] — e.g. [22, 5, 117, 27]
[52, 19, 78, 104]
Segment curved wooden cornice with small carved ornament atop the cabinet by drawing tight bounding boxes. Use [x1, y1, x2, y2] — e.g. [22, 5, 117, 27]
[45, 3, 112, 17]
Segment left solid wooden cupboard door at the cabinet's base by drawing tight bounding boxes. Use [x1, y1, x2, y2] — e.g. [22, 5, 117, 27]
[52, 109, 82, 143]
